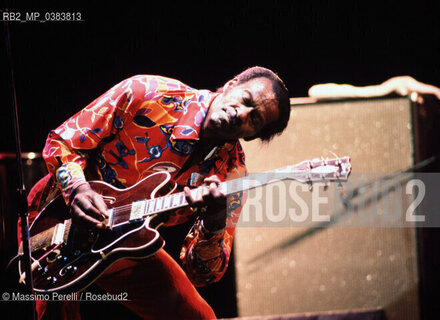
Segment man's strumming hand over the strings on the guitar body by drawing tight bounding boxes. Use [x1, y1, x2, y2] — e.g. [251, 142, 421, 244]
[70, 183, 108, 229]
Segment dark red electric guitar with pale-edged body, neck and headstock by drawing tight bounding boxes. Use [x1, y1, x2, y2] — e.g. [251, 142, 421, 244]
[19, 157, 351, 293]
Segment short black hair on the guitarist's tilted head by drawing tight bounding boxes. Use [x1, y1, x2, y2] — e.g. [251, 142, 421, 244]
[235, 66, 290, 142]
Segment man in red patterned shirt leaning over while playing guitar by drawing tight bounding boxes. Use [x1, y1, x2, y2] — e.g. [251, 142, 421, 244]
[28, 67, 290, 319]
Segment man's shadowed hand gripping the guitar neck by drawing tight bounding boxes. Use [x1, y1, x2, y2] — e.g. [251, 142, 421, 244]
[183, 176, 226, 232]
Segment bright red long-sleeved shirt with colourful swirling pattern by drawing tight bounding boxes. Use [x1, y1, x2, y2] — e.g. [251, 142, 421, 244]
[43, 75, 246, 286]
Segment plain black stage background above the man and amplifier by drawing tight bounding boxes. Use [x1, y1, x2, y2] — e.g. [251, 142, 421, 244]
[0, 0, 440, 316]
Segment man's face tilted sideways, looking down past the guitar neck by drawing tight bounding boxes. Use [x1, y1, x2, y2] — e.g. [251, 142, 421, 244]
[202, 77, 279, 141]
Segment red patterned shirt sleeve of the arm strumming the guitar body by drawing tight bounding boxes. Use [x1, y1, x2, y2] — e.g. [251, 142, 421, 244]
[43, 76, 147, 202]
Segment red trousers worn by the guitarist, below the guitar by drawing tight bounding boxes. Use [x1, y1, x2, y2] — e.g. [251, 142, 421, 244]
[37, 250, 216, 320]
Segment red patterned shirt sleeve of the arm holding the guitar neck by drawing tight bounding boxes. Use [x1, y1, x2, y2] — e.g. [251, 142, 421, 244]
[180, 142, 246, 287]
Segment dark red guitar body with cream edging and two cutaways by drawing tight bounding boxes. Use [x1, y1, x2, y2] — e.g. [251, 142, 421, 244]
[19, 172, 175, 293]
